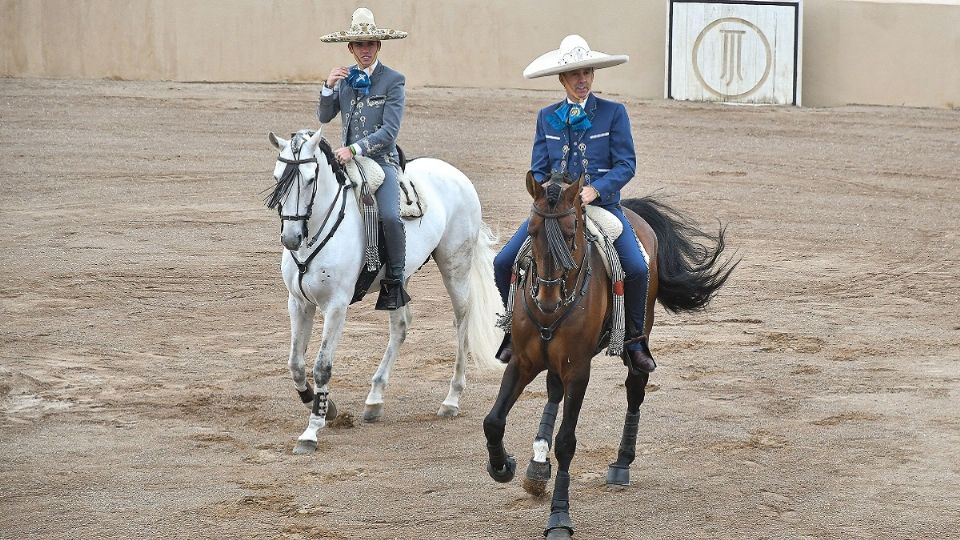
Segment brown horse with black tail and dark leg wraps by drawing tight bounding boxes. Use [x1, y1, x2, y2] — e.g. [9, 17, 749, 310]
[483, 173, 737, 539]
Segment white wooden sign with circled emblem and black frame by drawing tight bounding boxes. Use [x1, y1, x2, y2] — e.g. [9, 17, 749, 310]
[665, 0, 803, 106]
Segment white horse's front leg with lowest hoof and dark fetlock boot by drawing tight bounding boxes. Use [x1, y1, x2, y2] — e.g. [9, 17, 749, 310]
[293, 304, 347, 454]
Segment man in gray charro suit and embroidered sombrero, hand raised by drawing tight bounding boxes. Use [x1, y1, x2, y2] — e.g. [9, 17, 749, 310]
[317, 8, 410, 310]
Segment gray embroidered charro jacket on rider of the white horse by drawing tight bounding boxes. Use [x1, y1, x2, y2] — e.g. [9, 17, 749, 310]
[317, 62, 406, 163]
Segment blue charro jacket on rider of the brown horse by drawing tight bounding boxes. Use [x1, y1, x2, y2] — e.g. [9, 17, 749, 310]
[530, 93, 637, 206]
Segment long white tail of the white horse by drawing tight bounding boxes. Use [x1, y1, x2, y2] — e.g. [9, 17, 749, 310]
[464, 221, 503, 369]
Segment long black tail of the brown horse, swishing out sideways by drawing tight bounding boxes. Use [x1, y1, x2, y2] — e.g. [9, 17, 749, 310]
[620, 197, 740, 313]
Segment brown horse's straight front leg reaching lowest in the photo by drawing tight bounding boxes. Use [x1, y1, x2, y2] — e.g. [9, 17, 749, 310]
[543, 370, 590, 540]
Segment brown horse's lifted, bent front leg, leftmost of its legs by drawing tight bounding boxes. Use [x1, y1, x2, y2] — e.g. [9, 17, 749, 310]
[483, 356, 542, 483]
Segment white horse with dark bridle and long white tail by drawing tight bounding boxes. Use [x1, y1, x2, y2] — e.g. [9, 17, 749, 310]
[268, 130, 503, 454]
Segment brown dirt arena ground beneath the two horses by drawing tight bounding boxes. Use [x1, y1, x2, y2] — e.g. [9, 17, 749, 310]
[0, 77, 960, 539]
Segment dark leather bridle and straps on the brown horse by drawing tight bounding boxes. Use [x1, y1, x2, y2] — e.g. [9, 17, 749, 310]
[523, 200, 593, 341]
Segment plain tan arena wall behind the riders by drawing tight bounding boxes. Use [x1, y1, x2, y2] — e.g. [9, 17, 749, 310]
[0, 0, 960, 107]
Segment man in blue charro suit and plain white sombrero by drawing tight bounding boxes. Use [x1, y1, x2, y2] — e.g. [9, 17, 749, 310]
[494, 35, 656, 373]
